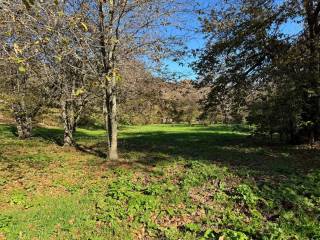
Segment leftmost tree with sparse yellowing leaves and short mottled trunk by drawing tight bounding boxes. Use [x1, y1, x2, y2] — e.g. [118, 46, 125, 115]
[0, 1, 56, 139]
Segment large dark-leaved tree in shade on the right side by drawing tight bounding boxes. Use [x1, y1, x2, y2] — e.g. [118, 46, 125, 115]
[194, 0, 320, 143]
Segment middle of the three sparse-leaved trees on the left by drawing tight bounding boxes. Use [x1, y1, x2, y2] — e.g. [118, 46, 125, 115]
[46, 1, 98, 146]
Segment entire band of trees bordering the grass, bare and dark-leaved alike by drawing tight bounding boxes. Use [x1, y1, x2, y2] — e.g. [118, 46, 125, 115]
[0, 0, 320, 163]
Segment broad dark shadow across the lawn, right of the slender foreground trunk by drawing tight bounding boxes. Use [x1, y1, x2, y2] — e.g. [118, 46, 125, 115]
[119, 127, 320, 175]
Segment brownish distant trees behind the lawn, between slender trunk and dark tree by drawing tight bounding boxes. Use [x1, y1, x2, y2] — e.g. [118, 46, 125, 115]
[118, 61, 205, 124]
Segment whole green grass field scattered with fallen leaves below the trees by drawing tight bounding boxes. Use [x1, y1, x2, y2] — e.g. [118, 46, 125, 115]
[0, 125, 320, 240]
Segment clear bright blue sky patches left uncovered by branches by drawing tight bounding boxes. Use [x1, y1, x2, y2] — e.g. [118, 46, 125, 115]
[165, 0, 302, 80]
